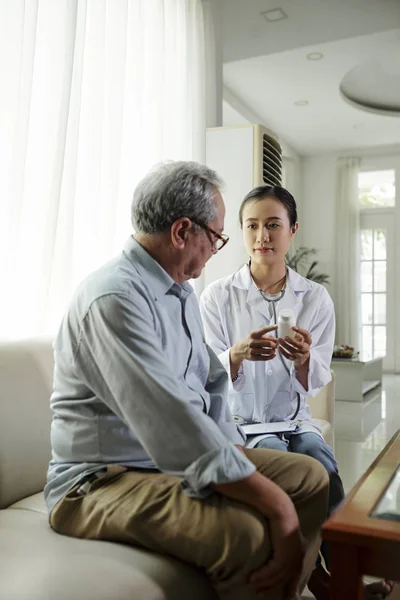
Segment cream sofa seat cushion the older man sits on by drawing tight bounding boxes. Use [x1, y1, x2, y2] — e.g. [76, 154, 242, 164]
[0, 494, 217, 600]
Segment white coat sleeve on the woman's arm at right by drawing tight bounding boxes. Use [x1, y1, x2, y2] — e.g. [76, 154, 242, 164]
[290, 292, 335, 397]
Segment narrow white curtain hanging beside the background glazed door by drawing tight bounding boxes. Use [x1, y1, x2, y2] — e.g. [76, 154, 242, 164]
[335, 158, 361, 350]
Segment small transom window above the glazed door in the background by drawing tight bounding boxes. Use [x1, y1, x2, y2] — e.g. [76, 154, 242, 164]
[358, 169, 396, 208]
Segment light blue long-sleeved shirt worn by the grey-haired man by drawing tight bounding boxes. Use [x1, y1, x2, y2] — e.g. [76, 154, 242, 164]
[45, 237, 255, 510]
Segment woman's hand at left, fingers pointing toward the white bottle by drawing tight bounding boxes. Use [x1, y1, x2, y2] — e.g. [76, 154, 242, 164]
[229, 325, 278, 377]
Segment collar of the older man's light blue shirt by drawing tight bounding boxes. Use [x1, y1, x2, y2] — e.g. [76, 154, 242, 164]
[123, 235, 193, 299]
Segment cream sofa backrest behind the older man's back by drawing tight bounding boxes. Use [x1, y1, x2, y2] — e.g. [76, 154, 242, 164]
[0, 338, 53, 508]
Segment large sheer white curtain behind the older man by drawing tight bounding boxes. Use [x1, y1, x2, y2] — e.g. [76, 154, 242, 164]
[0, 0, 206, 338]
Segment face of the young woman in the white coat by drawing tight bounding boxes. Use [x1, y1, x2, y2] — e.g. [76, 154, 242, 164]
[242, 198, 298, 264]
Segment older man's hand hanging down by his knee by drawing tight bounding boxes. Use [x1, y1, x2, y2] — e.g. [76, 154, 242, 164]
[249, 507, 305, 600]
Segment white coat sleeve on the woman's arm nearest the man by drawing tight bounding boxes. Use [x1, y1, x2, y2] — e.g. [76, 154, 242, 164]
[200, 286, 245, 392]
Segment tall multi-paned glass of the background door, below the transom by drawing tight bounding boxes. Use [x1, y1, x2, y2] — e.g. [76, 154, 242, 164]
[361, 229, 387, 356]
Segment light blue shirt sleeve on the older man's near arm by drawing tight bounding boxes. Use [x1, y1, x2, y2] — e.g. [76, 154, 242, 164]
[75, 293, 255, 497]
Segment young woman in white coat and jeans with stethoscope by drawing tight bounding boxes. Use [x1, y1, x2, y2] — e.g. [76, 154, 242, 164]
[200, 186, 390, 599]
